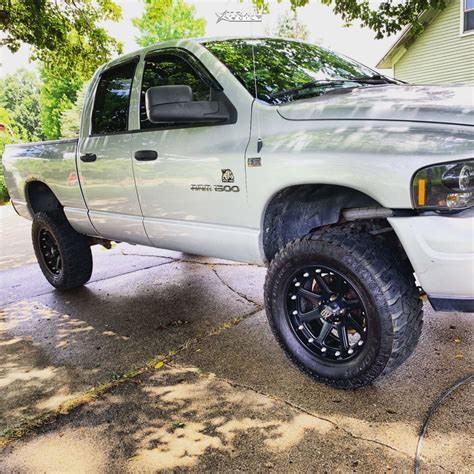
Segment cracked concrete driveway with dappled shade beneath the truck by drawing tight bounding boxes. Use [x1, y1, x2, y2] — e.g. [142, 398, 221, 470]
[0, 206, 474, 473]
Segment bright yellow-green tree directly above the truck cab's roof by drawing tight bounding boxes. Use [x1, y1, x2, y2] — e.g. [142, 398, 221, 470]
[132, 0, 206, 46]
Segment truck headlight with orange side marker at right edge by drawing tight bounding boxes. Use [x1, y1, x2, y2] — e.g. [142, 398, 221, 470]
[413, 160, 474, 211]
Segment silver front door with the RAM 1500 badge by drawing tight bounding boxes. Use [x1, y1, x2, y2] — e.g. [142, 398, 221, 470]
[132, 49, 251, 260]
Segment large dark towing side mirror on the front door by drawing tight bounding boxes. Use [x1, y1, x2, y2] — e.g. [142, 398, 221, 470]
[145, 86, 229, 123]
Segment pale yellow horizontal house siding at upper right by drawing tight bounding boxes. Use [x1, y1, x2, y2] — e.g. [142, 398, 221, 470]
[393, 0, 474, 85]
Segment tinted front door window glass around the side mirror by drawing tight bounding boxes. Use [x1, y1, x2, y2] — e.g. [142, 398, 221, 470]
[140, 54, 210, 128]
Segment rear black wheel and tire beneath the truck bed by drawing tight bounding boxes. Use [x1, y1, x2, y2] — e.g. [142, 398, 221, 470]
[32, 211, 92, 290]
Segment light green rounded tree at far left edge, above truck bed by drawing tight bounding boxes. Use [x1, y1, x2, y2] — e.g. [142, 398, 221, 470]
[0, 69, 42, 141]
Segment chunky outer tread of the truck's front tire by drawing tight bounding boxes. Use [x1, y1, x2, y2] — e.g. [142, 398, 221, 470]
[265, 224, 423, 389]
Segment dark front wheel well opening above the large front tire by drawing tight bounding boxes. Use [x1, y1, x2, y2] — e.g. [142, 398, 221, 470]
[263, 184, 411, 274]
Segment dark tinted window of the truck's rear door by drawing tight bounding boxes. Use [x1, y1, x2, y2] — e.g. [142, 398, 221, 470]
[92, 62, 136, 134]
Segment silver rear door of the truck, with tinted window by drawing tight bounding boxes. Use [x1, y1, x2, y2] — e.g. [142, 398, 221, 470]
[77, 59, 149, 244]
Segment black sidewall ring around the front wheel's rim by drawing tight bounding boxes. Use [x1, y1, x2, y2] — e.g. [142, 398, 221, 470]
[266, 240, 393, 381]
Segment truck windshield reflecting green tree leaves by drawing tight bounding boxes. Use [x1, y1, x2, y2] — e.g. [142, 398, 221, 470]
[204, 38, 380, 104]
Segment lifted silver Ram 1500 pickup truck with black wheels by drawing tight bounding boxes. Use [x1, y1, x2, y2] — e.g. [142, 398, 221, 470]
[3, 38, 474, 388]
